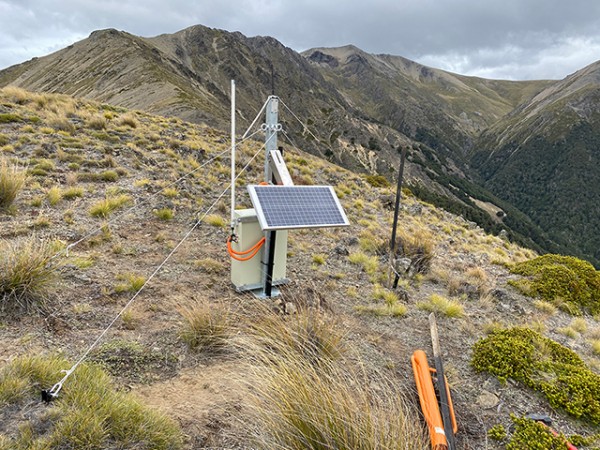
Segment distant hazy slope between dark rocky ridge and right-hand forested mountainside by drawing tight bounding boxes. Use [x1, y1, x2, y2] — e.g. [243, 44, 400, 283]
[303, 45, 550, 160]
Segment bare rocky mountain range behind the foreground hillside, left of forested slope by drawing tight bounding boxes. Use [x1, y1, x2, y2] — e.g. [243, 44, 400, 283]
[0, 25, 568, 262]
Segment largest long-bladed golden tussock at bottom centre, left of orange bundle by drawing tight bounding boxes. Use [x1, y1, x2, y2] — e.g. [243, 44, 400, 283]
[243, 311, 427, 450]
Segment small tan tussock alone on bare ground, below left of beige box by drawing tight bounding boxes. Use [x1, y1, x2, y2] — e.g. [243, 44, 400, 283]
[179, 303, 234, 354]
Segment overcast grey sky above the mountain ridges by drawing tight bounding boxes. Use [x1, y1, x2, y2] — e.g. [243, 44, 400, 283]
[0, 0, 600, 80]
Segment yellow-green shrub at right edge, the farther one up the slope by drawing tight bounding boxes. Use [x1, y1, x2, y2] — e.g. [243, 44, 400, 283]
[511, 255, 600, 314]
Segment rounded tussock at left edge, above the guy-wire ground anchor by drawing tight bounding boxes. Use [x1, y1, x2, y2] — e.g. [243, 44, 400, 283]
[0, 237, 58, 310]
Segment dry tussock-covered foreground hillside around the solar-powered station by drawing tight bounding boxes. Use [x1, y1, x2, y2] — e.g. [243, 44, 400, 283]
[0, 87, 600, 450]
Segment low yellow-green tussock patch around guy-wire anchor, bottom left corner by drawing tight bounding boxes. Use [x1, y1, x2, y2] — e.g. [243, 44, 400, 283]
[0, 356, 183, 450]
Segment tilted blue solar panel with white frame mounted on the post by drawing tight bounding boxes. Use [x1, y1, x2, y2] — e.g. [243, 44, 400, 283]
[248, 185, 349, 231]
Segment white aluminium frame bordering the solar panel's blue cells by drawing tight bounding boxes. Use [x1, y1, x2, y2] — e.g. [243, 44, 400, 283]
[248, 185, 350, 231]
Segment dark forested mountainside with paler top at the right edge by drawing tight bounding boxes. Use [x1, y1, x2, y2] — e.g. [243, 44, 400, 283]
[472, 62, 600, 264]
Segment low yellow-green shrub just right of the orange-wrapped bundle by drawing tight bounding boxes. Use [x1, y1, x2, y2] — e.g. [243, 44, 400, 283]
[471, 328, 600, 425]
